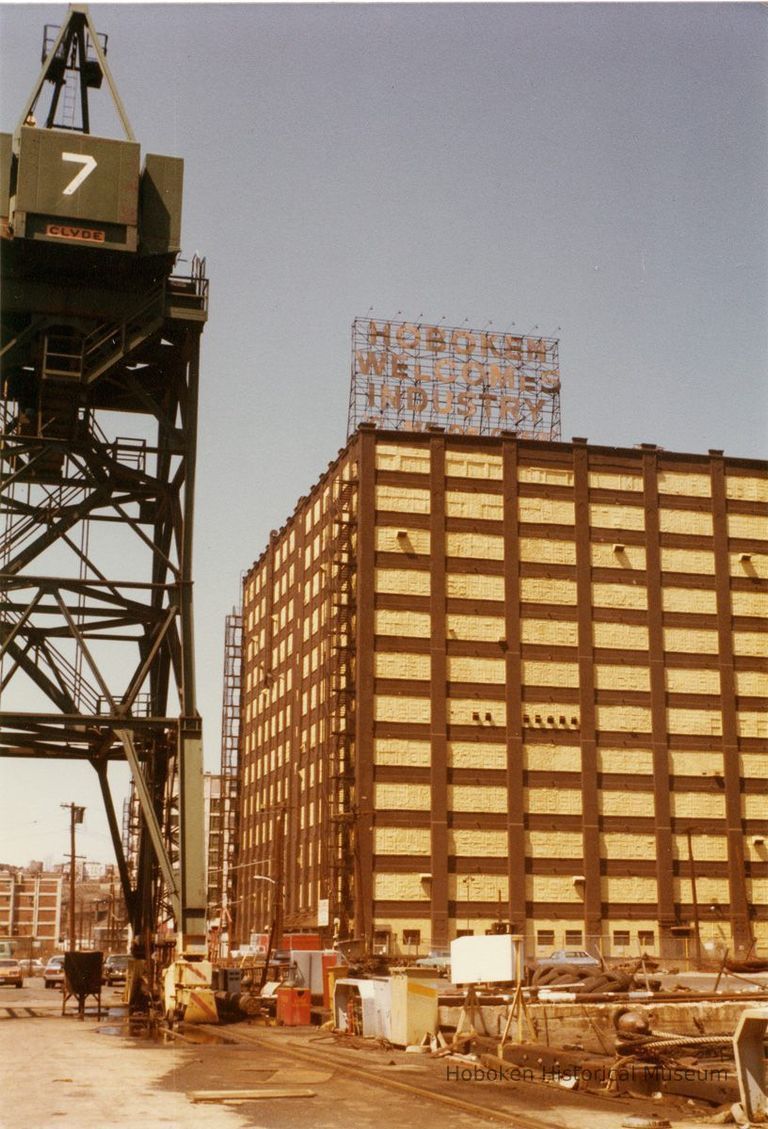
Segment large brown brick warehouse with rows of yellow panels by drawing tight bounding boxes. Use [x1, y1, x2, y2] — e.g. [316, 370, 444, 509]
[236, 425, 768, 955]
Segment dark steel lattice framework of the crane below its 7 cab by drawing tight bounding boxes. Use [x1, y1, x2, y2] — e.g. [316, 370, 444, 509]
[0, 272, 207, 948]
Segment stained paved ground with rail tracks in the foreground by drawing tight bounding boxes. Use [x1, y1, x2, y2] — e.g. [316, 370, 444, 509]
[0, 981, 745, 1129]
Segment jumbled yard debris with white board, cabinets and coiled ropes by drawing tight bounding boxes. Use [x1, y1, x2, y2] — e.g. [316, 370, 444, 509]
[205, 935, 768, 1124]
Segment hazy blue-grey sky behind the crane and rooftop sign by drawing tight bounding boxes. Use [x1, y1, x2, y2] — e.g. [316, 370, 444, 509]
[0, 3, 768, 863]
